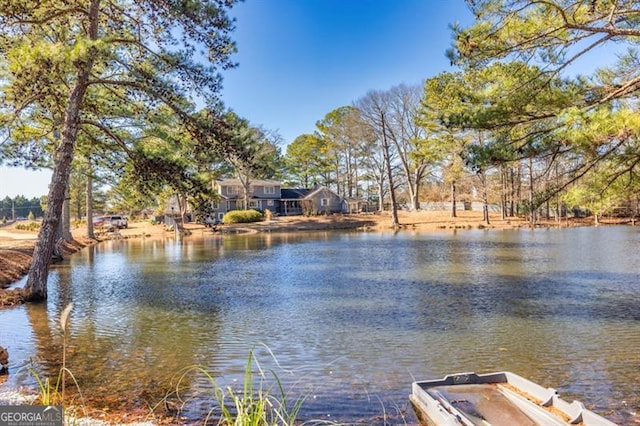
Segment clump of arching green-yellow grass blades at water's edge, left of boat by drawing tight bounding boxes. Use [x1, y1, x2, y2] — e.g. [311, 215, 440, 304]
[158, 349, 304, 426]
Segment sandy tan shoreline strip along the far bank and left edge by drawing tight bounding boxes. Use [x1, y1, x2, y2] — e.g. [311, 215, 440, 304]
[0, 211, 633, 296]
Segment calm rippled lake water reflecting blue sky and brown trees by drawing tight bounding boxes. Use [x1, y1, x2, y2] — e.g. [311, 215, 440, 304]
[0, 227, 640, 424]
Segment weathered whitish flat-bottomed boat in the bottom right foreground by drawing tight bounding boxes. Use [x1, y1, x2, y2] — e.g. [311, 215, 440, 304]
[411, 372, 615, 426]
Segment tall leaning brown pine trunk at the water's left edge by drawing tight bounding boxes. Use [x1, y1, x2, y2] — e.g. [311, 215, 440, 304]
[24, 0, 100, 301]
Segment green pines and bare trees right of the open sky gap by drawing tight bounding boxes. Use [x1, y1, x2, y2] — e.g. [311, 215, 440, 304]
[286, 0, 640, 228]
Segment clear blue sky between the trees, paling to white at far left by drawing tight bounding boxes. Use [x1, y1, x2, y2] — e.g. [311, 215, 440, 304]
[0, 0, 620, 198]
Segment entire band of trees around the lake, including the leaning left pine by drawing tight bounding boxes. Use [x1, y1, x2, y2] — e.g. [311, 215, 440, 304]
[0, 0, 640, 299]
